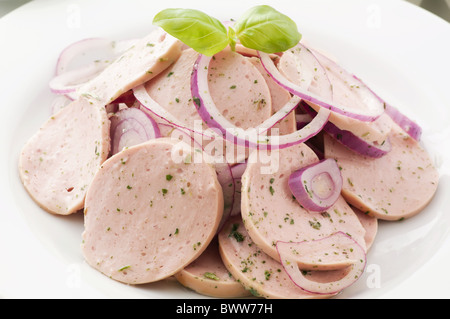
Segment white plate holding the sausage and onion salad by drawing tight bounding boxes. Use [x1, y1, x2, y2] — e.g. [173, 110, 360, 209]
[0, 0, 450, 298]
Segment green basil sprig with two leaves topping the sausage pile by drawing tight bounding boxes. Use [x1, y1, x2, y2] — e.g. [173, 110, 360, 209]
[153, 5, 301, 56]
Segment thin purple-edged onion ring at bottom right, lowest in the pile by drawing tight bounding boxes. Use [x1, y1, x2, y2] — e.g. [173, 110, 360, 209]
[276, 232, 367, 294]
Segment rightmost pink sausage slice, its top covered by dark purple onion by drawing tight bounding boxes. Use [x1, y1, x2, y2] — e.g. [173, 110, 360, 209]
[324, 119, 439, 220]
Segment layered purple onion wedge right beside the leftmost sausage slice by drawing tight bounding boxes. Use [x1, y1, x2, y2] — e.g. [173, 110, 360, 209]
[110, 108, 161, 155]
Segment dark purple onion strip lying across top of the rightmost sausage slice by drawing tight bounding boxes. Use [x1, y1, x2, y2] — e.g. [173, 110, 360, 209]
[300, 101, 392, 158]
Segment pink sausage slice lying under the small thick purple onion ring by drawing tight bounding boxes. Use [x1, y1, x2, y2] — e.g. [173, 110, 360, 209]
[241, 144, 365, 264]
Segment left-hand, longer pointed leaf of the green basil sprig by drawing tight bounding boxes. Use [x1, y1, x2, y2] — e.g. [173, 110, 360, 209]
[153, 8, 229, 56]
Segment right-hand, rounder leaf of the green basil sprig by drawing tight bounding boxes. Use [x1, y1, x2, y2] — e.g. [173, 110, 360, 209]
[235, 5, 302, 53]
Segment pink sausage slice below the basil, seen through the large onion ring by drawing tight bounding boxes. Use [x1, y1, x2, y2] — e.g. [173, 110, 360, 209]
[146, 49, 272, 163]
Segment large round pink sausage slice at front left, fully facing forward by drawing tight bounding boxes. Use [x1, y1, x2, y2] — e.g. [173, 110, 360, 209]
[82, 138, 223, 284]
